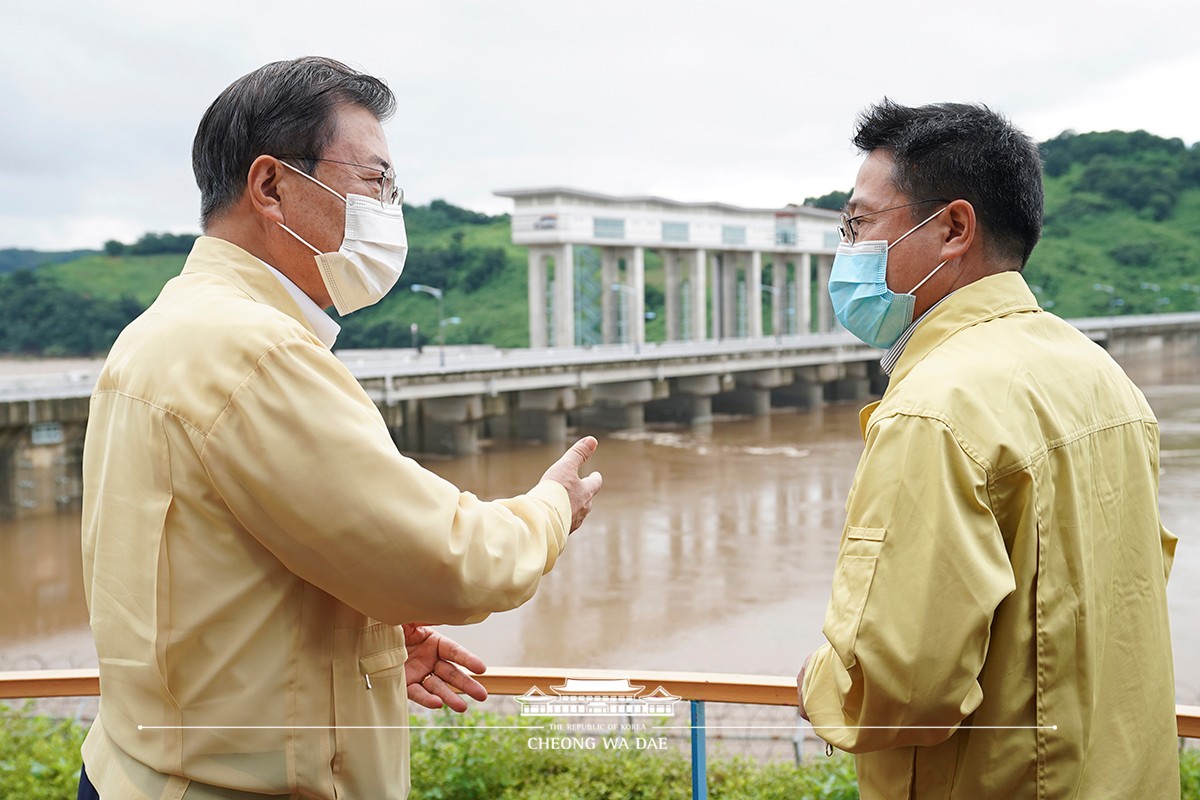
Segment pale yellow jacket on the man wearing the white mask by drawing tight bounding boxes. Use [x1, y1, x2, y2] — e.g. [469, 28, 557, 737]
[83, 237, 571, 800]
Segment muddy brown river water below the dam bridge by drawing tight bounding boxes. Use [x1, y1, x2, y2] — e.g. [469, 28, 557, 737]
[0, 347, 1200, 704]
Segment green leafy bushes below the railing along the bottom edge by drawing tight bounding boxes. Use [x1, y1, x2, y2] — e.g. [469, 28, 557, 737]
[7, 703, 1200, 800]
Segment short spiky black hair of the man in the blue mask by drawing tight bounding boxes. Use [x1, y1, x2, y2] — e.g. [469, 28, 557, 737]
[852, 97, 1044, 267]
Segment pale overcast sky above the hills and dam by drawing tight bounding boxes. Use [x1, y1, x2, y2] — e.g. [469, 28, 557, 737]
[0, 0, 1200, 249]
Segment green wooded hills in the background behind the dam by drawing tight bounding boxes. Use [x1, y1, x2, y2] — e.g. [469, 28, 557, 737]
[0, 131, 1200, 354]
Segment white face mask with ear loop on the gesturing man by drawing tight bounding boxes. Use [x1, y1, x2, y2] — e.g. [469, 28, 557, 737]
[278, 161, 408, 315]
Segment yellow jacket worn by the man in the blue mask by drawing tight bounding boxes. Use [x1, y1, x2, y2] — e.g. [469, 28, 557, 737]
[802, 272, 1180, 800]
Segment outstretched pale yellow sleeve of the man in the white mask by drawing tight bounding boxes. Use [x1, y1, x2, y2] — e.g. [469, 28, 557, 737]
[202, 341, 571, 625]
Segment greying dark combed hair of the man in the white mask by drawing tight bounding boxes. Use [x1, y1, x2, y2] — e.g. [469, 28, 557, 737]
[192, 56, 396, 229]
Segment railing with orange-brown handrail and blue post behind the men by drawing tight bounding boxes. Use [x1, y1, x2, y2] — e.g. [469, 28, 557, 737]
[7, 667, 1200, 800]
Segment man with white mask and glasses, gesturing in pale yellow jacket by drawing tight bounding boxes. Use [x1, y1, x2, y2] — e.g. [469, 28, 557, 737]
[80, 58, 600, 800]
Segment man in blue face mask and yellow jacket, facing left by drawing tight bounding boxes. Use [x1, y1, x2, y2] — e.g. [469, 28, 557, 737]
[798, 100, 1180, 800]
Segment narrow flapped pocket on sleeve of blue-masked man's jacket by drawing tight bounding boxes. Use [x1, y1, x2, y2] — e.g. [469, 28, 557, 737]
[823, 528, 887, 669]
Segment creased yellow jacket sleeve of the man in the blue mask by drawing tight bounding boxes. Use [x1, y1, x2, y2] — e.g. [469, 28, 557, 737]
[802, 415, 1016, 753]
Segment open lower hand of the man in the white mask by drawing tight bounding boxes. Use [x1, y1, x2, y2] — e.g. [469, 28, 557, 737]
[402, 624, 487, 714]
